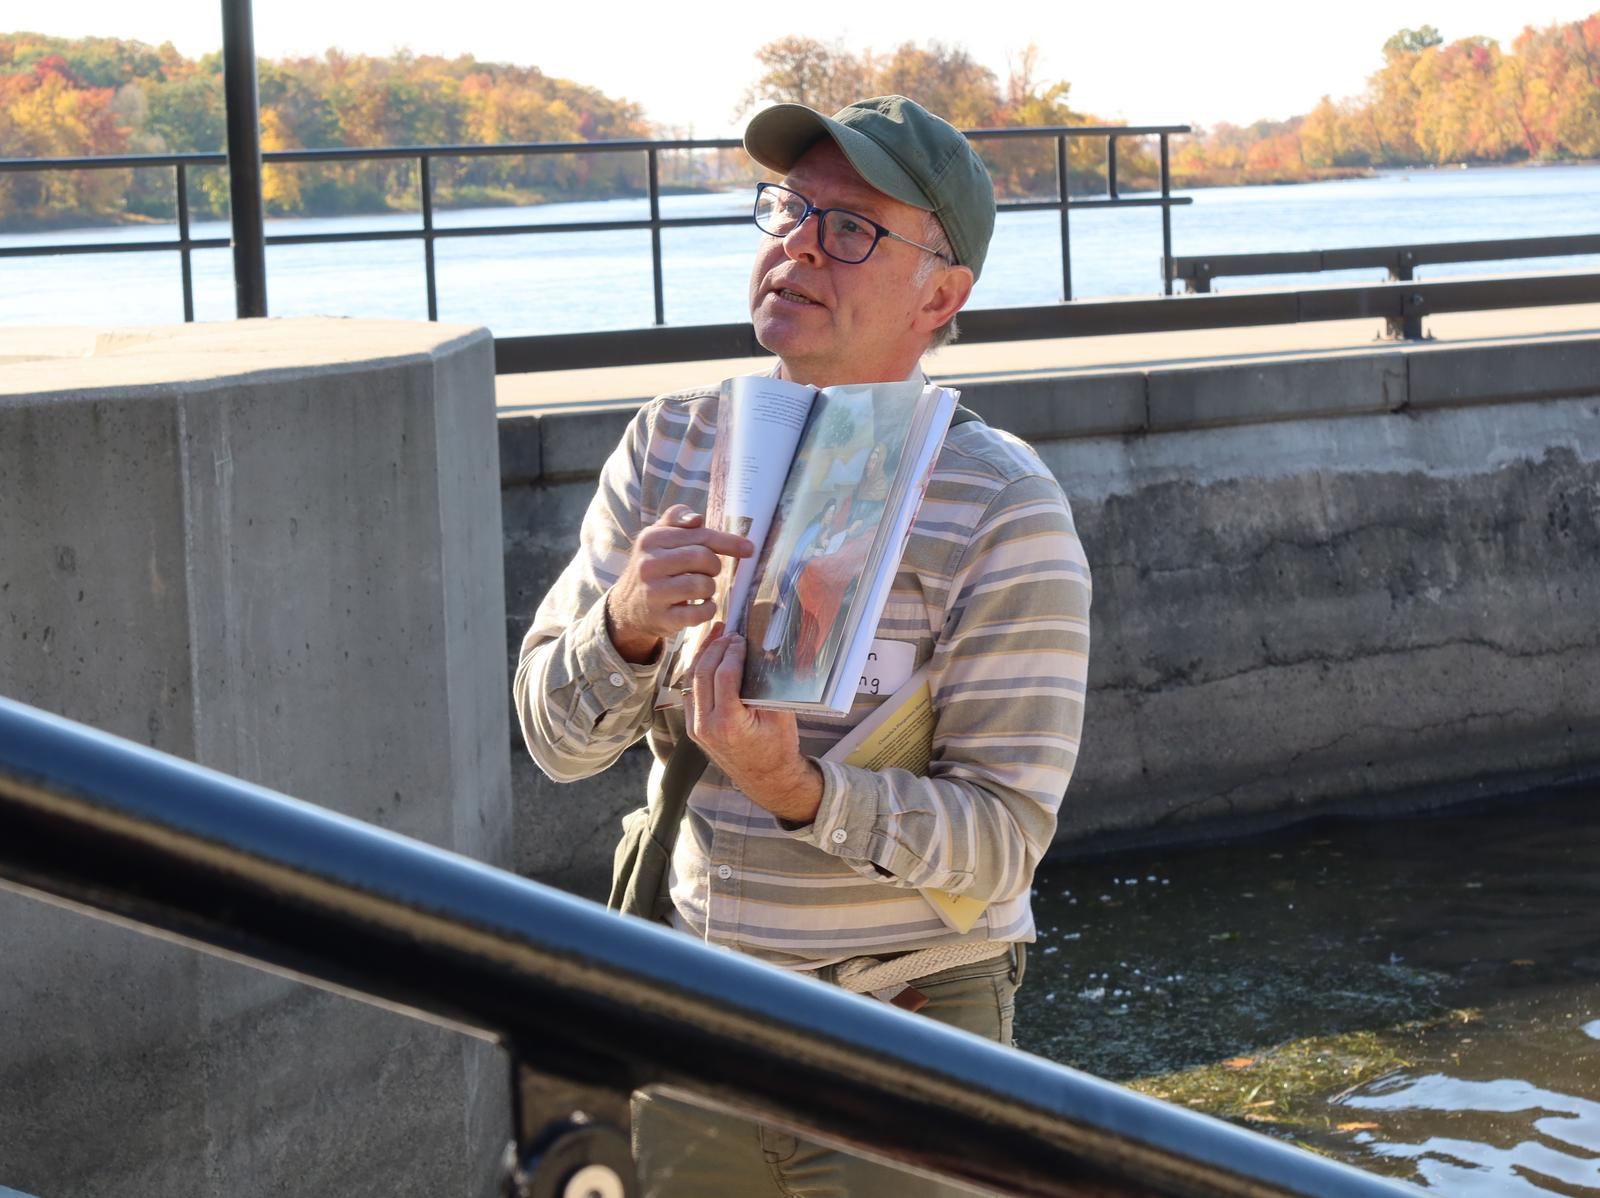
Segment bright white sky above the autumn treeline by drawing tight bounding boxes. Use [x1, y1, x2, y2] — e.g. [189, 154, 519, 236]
[25, 0, 1600, 138]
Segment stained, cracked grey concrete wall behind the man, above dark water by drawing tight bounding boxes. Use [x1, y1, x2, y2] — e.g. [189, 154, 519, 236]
[501, 336, 1600, 894]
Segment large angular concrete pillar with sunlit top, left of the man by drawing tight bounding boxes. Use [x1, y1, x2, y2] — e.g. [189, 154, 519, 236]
[0, 320, 510, 1198]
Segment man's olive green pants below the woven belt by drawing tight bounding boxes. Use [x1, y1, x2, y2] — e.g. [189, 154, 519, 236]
[634, 945, 1022, 1198]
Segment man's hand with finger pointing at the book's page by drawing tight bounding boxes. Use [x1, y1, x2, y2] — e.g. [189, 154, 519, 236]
[605, 504, 755, 664]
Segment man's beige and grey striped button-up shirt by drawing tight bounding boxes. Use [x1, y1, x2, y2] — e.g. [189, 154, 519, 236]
[515, 379, 1090, 968]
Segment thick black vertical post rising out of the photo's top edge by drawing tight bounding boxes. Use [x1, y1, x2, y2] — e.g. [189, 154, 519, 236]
[222, 0, 267, 320]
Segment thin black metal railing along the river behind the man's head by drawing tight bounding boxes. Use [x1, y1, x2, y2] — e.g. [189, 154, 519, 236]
[0, 125, 1192, 326]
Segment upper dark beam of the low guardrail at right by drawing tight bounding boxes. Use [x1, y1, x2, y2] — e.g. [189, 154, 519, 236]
[1162, 234, 1600, 341]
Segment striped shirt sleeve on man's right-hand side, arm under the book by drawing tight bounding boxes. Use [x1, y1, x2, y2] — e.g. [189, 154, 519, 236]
[792, 475, 1091, 902]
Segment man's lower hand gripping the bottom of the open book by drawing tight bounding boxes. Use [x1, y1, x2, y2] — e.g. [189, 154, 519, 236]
[683, 629, 822, 824]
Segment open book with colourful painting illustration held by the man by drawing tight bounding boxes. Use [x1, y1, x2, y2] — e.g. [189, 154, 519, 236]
[680, 376, 957, 713]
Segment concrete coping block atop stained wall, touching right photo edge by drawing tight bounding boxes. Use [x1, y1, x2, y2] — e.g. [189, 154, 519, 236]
[1406, 337, 1600, 408]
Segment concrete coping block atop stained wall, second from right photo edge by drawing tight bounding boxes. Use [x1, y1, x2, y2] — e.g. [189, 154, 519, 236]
[1149, 350, 1406, 432]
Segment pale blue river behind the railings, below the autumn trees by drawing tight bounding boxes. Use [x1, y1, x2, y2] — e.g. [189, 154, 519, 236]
[0, 166, 1600, 336]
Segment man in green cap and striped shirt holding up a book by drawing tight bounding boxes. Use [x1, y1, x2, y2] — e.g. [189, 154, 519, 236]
[515, 96, 1090, 1195]
